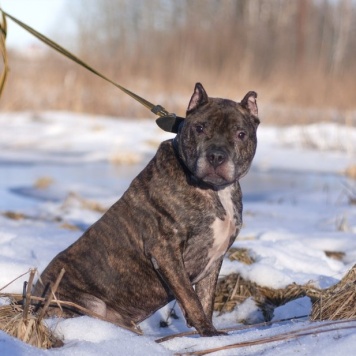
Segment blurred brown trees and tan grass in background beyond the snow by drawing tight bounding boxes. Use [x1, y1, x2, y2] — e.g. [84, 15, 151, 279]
[1, 0, 356, 121]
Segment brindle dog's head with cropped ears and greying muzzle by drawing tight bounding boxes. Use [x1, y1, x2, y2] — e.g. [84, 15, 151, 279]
[176, 83, 260, 188]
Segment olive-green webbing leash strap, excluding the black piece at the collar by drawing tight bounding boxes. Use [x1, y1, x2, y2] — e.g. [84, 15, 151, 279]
[0, 9, 170, 117]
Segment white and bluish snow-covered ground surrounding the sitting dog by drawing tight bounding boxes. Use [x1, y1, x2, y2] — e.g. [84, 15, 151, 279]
[0, 112, 356, 356]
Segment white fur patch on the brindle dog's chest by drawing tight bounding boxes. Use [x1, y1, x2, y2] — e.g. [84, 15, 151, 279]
[195, 186, 240, 281]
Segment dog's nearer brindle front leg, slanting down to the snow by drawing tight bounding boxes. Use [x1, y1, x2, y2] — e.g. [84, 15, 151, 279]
[146, 245, 220, 336]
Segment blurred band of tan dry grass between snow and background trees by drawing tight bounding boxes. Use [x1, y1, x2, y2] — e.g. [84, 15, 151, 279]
[1, 53, 355, 126]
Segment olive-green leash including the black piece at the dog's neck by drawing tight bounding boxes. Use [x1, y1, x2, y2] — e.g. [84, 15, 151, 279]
[0, 8, 184, 133]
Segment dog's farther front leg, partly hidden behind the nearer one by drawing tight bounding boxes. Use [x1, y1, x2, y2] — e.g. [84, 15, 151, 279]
[195, 257, 223, 321]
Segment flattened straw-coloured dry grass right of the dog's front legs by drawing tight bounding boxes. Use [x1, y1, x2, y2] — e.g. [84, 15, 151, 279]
[214, 249, 356, 321]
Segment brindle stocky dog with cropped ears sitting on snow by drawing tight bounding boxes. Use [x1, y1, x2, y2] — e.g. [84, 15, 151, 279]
[34, 83, 260, 336]
